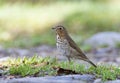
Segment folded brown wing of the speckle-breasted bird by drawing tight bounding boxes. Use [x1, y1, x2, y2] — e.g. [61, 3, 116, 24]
[66, 36, 89, 61]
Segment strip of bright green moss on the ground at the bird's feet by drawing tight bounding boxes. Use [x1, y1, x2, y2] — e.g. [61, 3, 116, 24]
[0, 56, 120, 81]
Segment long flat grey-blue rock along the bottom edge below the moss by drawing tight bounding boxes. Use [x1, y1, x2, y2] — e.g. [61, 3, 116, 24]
[0, 75, 95, 83]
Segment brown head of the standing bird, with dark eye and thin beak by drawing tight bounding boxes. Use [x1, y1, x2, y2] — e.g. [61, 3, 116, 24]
[52, 25, 67, 37]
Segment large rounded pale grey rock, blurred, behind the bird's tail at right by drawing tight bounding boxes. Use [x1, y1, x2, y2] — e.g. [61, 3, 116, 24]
[85, 32, 120, 47]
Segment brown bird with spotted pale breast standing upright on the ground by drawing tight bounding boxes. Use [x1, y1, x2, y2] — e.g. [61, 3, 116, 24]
[52, 25, 97, 67]
